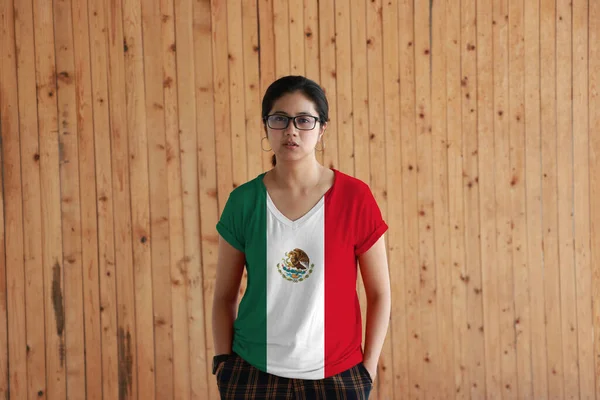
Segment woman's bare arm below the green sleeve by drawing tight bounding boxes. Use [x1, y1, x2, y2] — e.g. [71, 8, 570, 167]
[212, 236, 246, 355]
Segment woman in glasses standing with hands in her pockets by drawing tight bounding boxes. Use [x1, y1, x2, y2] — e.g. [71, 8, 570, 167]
[213, 76, 391, 399]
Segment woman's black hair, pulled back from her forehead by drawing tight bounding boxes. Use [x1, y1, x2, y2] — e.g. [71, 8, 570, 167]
[262, 75, 329, 166]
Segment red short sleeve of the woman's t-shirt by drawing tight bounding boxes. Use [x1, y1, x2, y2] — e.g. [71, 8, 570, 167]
[354, 187, 388, 256]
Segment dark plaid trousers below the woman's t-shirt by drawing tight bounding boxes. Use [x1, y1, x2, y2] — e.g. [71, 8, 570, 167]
[216, 354, 373, 400]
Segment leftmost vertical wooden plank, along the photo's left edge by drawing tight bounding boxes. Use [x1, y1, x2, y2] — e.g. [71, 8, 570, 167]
[0, 1, 28, 399]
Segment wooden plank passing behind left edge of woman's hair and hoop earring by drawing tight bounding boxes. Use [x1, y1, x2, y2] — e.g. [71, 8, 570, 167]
[257, 0, 276, 171]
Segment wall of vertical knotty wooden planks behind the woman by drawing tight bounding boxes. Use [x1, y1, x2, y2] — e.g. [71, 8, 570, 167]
[0, 0, 600, 400]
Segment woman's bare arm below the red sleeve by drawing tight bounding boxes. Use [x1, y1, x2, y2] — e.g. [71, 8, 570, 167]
[358, 236, 392, 379]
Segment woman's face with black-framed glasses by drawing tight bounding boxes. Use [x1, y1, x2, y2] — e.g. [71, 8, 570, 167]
[265, 92, 327, 162]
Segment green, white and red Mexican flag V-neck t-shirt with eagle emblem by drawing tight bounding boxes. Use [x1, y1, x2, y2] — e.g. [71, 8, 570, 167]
[217, 170, 387, 379]
